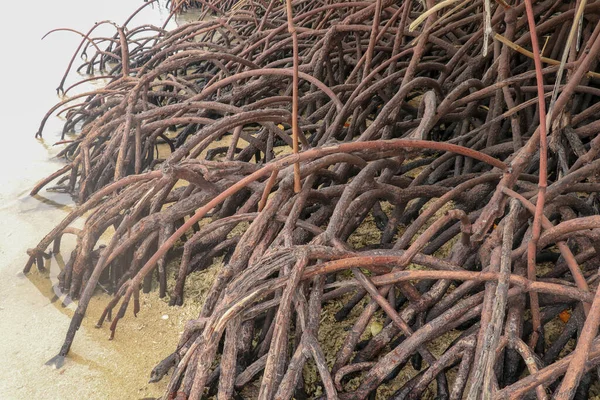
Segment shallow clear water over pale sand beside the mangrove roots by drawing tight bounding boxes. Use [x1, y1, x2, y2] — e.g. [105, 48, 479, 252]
[0, 0, 202, 399]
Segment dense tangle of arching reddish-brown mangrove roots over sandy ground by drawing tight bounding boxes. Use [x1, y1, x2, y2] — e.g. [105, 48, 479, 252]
[25, 0, 600, 399]
